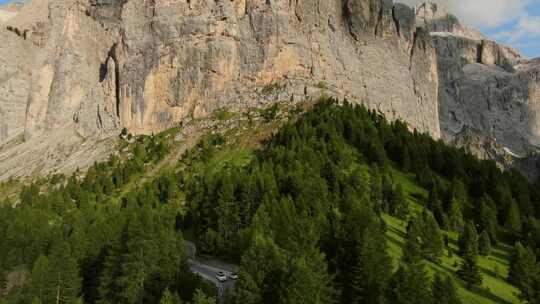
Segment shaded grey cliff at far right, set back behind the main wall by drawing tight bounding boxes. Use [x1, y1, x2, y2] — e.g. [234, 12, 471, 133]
[417, 4, 540, 157]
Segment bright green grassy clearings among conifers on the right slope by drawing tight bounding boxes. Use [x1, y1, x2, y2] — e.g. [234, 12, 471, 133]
[384, 171, 519, 304]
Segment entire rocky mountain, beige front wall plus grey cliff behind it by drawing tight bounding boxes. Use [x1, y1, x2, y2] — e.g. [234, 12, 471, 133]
[0, 0, 539, 179]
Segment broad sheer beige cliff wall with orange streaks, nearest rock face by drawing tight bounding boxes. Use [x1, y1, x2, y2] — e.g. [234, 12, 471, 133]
[0, 0, 440, 179]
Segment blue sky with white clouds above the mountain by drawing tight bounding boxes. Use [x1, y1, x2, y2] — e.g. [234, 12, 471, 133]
[0, 0, 540, 58]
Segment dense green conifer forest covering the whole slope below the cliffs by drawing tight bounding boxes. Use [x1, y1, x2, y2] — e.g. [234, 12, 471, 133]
[0, 98, 540, 304]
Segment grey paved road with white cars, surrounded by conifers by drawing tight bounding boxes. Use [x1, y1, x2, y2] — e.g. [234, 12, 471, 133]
[186, 242, 237, 303]
